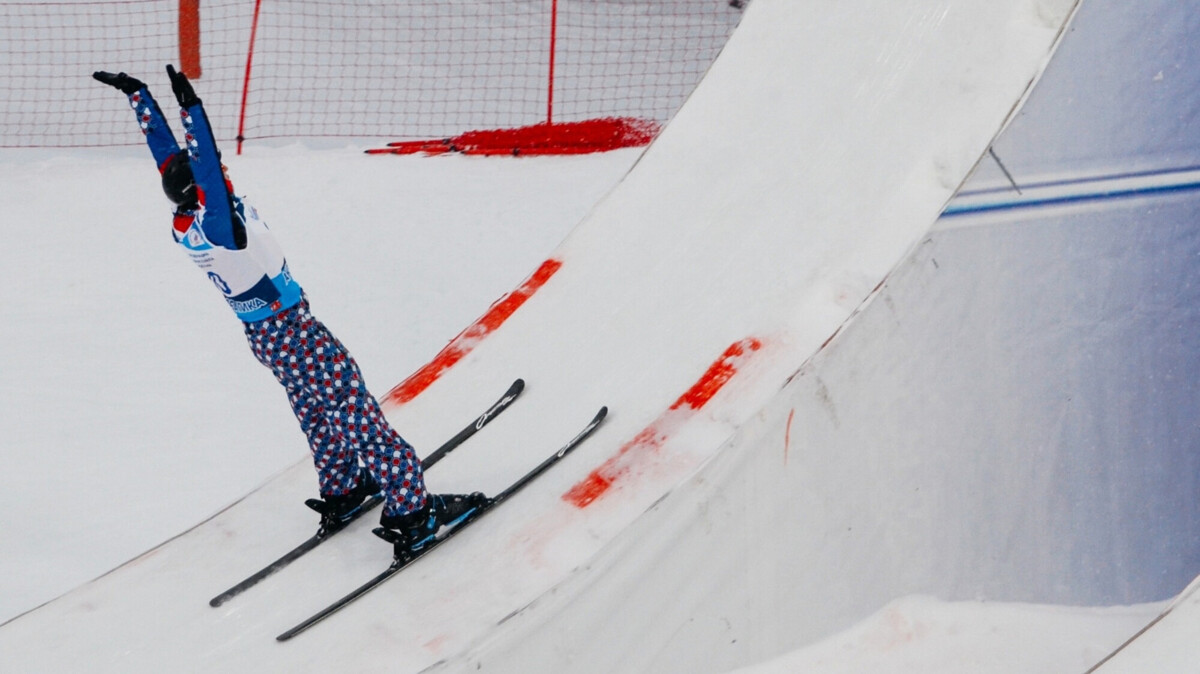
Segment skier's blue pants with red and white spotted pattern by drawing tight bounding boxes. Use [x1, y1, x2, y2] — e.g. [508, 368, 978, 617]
[245, 300, 426, 516]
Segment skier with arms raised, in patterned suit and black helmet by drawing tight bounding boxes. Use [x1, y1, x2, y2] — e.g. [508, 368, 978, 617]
[92, 65, 487, 552]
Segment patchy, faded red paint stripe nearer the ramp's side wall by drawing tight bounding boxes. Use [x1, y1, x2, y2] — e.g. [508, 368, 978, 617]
[563, 337, 762, 508]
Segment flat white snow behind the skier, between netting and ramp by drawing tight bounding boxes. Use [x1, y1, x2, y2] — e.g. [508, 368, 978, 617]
[0, 144, 640, 621]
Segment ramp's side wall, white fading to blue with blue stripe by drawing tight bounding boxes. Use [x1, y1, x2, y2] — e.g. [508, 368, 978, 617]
[440, 0, 1200, 673]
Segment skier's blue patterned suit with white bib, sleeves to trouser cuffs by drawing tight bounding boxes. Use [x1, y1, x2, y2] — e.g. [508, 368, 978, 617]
[130, 88, 426, 516]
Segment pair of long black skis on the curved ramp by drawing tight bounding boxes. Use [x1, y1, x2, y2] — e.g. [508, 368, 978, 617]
[209, 379, 608, 642]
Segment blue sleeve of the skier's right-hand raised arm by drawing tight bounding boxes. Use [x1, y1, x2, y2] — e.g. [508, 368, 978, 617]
[182, 101, 245, 249]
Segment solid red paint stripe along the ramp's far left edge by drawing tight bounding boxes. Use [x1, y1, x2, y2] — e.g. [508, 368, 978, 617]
[380, 259, 563, 405]
